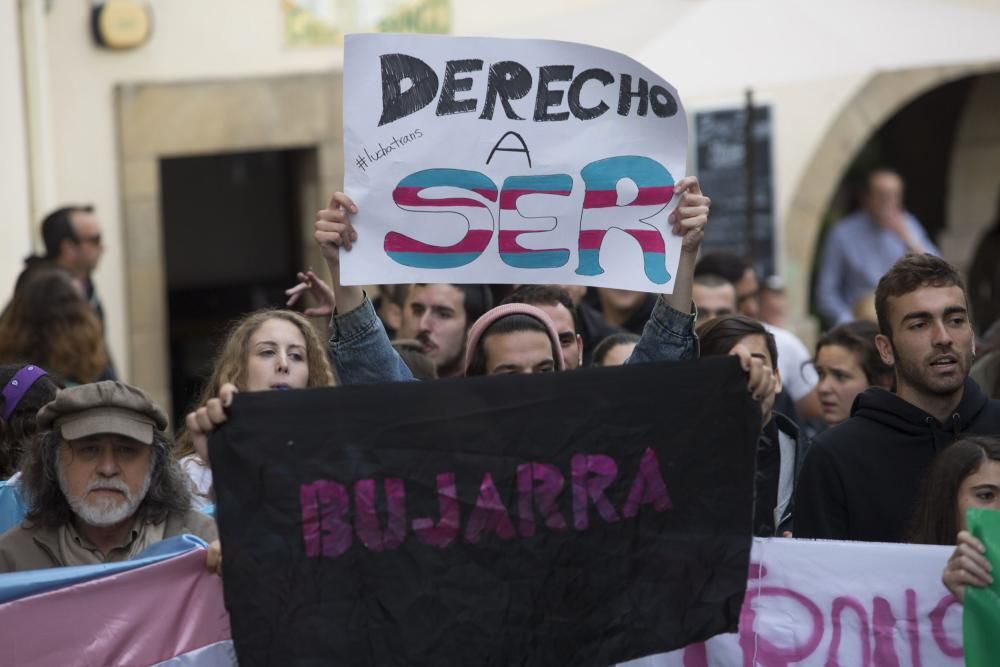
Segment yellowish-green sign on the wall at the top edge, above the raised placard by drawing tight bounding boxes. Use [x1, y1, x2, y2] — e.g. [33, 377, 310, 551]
[281, 0, 451, 46]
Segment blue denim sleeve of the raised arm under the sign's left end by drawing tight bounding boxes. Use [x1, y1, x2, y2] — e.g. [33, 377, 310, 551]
[329, 296, 416, 385]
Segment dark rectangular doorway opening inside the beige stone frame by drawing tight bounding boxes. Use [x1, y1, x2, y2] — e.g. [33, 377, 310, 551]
[160, 150, 316, 424]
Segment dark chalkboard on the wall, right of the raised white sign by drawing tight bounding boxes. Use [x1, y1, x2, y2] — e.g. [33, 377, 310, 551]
[694, 106, 776, 277]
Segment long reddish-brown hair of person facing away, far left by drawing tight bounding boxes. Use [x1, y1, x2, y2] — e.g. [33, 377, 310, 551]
[0, 269, 108, 384]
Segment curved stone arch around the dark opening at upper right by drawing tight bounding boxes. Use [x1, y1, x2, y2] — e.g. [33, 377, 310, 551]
[782, 62, 1000, 339]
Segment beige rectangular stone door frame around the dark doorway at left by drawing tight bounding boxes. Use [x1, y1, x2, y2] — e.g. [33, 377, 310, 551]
[115, 72, 343, 414]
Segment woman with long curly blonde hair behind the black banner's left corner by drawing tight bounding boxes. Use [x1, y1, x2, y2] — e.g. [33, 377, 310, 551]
[177, 310, 333, 506]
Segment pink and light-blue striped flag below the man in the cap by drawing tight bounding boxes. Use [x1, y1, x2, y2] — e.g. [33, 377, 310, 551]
[0, 535, 237, 667]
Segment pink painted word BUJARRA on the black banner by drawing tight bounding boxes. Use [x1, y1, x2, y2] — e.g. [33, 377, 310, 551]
[299, 447, 672, 558]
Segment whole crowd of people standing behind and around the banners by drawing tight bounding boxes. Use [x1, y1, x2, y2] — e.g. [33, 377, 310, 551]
[0, 169, 1000, 620]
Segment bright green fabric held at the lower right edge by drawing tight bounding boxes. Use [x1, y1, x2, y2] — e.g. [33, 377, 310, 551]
[962, 509, 1000, 667]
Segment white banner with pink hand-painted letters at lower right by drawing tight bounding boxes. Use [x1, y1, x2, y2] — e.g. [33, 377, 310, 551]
[626, 538, 964, 667]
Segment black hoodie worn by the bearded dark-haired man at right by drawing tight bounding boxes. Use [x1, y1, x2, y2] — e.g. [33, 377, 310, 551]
[795, 379, 1000, 542]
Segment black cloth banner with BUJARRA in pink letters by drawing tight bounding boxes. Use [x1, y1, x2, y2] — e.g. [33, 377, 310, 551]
[210, 358, 760, 667]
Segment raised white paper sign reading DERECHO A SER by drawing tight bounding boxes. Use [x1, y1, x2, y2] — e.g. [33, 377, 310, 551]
[341, 35, 687, 293]
